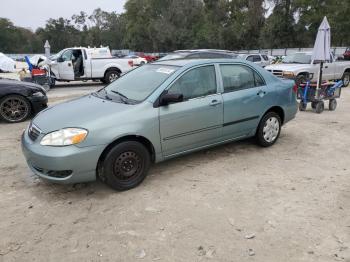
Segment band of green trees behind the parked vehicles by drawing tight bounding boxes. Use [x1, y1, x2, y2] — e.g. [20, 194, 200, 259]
[0, 0, 350, 53]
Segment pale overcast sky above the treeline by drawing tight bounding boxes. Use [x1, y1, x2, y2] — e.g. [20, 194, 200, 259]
[0, 0, 126, 30]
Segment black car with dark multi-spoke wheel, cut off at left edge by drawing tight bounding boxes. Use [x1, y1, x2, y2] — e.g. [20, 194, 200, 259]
[0, 78, 47, 123]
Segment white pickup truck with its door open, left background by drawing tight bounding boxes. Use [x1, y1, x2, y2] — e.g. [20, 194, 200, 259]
[50, 47, 134, 84]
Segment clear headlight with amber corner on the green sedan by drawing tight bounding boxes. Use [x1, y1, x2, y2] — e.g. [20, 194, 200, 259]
[40, 128, 88, 146]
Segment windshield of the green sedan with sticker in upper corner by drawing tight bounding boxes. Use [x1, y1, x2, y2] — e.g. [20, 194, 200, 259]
[99, 64, 179, 104]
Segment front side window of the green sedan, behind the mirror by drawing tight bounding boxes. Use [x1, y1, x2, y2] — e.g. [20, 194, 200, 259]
[168, 66, 217, 100]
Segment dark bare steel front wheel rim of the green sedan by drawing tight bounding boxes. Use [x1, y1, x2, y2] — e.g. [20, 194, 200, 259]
[113, 151, 143, 181]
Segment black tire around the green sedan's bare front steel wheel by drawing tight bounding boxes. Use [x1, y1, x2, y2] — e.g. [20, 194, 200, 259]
[102, 141, 151, 191]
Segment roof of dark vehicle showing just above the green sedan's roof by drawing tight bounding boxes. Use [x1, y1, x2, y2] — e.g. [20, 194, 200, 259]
[158, 49, 237, 61]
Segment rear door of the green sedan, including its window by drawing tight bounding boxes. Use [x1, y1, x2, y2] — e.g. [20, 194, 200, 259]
[220, 64, 274, 139]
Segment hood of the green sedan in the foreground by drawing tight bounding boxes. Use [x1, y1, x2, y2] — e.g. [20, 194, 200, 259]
[33, 95, 134, 133]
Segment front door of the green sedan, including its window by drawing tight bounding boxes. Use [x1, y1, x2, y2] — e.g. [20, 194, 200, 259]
[159, 65, 223, 157]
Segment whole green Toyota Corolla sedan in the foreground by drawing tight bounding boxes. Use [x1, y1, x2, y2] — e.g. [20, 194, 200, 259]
[22, 59, 297, 190]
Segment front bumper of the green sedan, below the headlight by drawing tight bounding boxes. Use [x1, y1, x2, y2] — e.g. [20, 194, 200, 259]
[22, 129, 105, 184]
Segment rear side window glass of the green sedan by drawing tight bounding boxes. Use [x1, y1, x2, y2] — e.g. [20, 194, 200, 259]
[220, 65, 265, 93]
